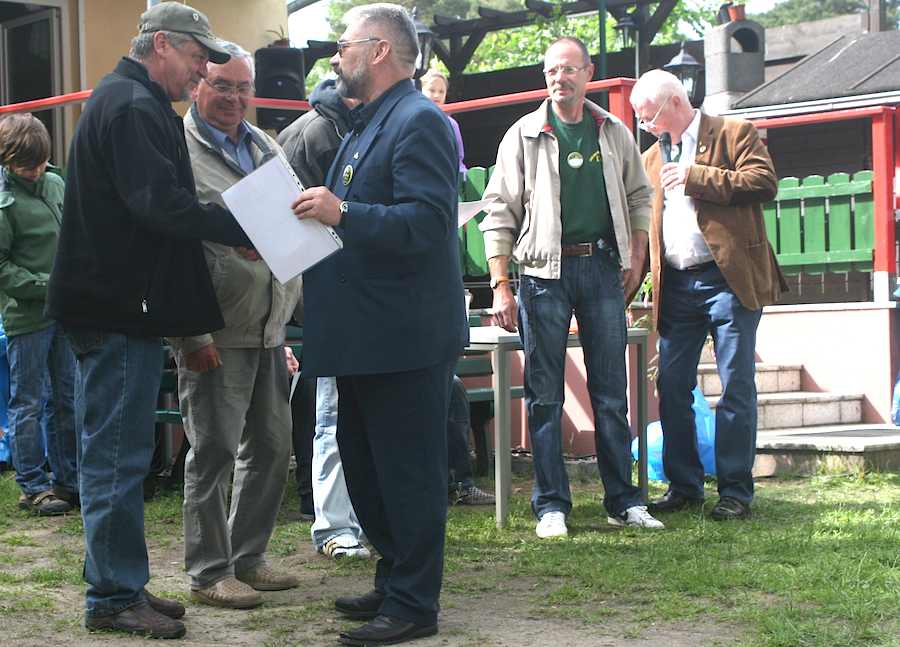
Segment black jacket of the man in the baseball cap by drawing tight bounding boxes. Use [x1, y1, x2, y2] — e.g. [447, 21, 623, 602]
[47, 58, 250, 337]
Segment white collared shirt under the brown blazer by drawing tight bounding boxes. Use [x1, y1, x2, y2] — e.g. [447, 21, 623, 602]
[662, 110, 713, 270]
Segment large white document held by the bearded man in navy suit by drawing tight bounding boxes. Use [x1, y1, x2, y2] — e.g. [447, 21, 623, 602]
[222, 156, 344, 283]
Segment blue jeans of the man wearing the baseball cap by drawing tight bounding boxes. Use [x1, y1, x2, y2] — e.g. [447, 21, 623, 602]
[67, 330, 163, 616]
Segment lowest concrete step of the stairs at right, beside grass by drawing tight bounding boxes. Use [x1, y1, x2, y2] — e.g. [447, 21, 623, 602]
[753, 423, 900, 477]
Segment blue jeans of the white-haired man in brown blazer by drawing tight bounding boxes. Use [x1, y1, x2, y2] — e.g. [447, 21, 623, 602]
[657, 264, 762, 504]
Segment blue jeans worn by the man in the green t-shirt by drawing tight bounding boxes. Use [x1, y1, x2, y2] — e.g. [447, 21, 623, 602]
[519, 246, 641, 518]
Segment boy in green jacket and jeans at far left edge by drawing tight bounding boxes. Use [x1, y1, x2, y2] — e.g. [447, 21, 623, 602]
[0, 114, 78, 515]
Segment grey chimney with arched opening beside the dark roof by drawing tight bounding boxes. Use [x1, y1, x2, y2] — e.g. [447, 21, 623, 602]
[703, 20, 766, 115]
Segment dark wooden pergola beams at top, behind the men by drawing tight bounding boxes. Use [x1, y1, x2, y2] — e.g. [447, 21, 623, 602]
[288, 0, 678, 79]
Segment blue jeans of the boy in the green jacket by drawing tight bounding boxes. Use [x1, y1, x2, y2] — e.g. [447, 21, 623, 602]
[8, 324, 78, 495]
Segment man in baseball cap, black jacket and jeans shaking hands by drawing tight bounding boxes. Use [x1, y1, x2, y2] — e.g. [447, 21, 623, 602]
[47, 2, 250, 638]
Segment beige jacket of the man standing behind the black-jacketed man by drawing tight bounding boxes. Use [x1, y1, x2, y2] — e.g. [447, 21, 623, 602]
[170, 110, 301, 353]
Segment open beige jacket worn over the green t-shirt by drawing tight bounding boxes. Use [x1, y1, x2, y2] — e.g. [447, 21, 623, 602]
[481, 99, 652, 279]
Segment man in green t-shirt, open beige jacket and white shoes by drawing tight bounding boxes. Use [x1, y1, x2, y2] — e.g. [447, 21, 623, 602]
[481, 38, 663, 538]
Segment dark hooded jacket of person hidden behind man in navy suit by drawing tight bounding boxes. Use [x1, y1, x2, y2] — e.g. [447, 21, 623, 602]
[278, 79, 350, 187]
